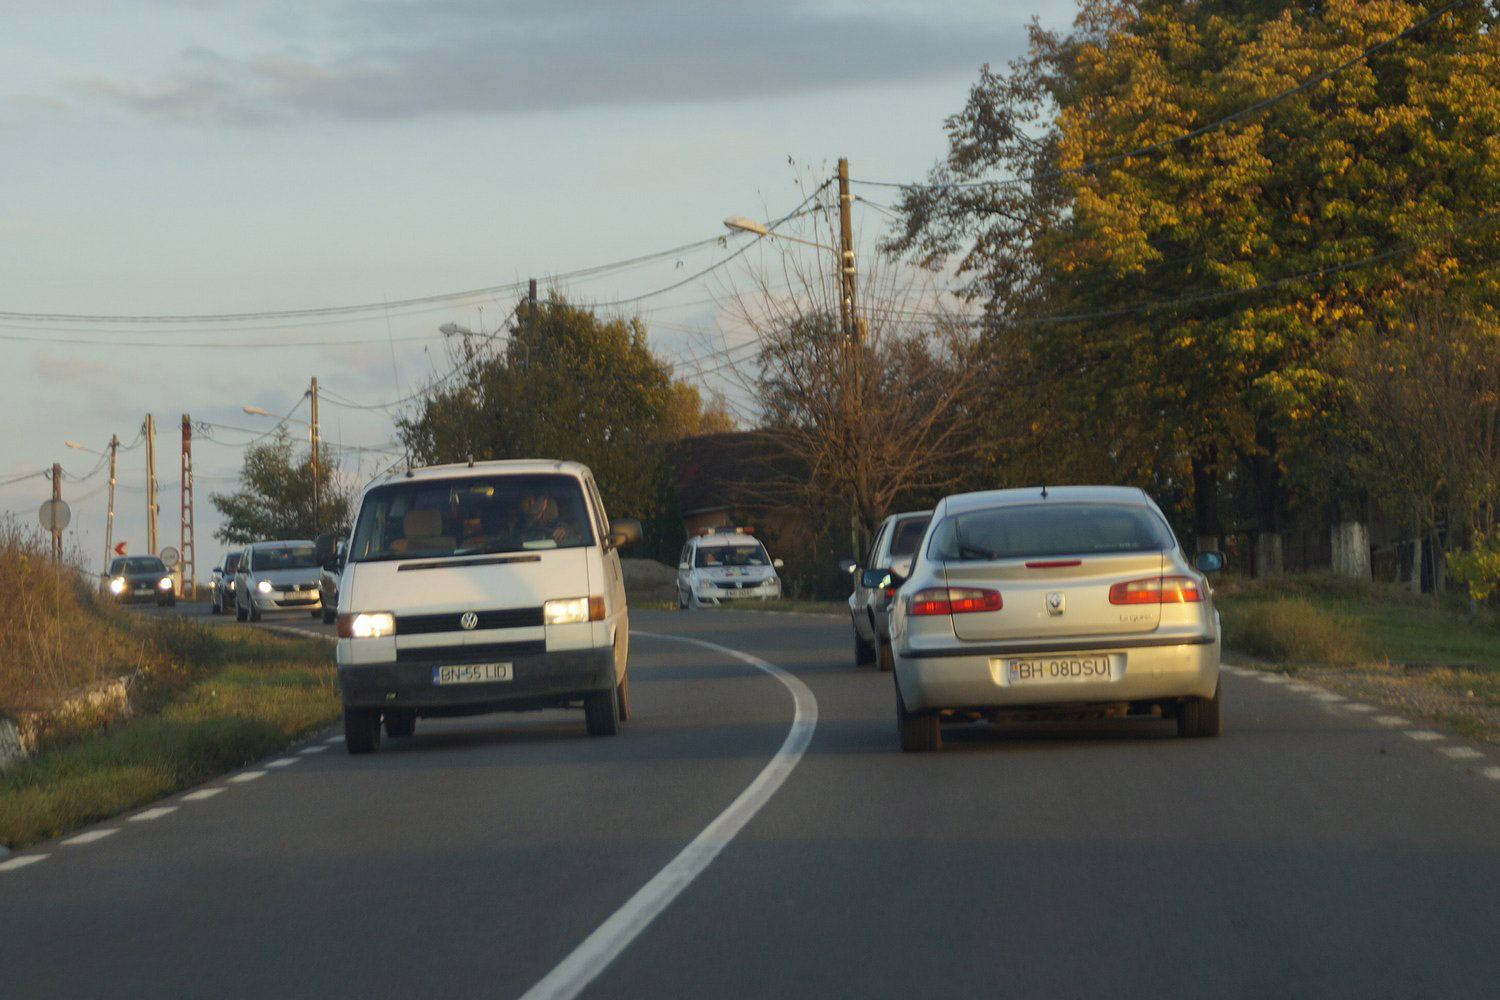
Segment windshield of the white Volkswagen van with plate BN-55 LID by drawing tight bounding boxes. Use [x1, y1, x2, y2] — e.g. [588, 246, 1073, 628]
[350, 474, 594, 562]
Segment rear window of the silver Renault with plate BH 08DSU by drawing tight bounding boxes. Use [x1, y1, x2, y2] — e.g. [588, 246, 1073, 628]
[929, 504, 1176, 562]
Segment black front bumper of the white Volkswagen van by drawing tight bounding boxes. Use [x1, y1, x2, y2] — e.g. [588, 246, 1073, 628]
[339, 646, 615, 715]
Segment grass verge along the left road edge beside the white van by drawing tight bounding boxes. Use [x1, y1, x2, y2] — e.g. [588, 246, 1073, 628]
[0, 624, 339, 849]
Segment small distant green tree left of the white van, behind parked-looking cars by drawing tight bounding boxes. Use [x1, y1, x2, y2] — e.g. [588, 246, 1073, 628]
[209, 427, 353, 544]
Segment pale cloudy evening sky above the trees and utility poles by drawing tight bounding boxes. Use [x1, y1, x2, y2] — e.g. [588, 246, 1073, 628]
[0, 0, 1076, 580]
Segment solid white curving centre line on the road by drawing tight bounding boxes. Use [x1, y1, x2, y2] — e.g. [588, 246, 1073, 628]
[522, 631, 818, 1000]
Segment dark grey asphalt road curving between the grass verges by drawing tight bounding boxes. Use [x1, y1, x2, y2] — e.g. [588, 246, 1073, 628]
[0, 610, 1500, 1000]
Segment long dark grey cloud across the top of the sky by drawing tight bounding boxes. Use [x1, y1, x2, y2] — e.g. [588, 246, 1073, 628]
[72, 0, 1025, 124]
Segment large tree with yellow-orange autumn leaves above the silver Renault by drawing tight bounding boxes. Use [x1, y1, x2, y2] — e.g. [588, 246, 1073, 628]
[893, 0, 1500, 568]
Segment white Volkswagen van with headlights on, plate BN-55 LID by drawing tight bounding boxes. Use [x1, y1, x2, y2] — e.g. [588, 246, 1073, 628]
[331, 460, 641, 754]
